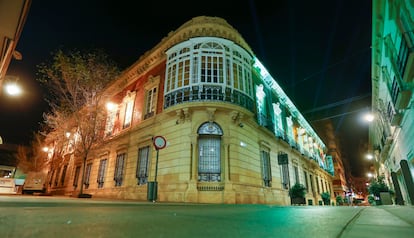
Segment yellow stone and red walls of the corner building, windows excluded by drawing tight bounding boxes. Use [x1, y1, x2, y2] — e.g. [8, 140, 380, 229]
[49, 17, 333, 205]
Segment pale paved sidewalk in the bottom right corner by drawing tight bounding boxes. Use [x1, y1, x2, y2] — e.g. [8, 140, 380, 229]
[340, 205, 414, 238]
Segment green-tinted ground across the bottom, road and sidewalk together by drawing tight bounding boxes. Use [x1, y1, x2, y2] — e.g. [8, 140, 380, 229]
[0, 195, 414, 238]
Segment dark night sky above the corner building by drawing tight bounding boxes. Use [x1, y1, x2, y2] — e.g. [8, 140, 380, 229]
[0, 0, 372, 177]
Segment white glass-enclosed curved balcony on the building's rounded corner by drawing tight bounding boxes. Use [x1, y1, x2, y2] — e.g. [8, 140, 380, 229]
[164, 37, 254, 112]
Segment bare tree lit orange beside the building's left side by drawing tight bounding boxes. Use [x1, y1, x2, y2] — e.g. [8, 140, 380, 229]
[38, 50, 119, 196]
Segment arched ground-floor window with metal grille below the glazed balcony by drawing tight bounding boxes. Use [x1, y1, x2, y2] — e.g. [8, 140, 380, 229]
[197, 122, 223, 182]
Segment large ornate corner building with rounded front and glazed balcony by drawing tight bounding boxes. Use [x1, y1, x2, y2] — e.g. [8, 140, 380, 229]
[50, 16, 334, 205]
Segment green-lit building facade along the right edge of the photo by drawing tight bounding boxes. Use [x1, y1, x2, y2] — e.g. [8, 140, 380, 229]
[369, 0, 414, 204]
